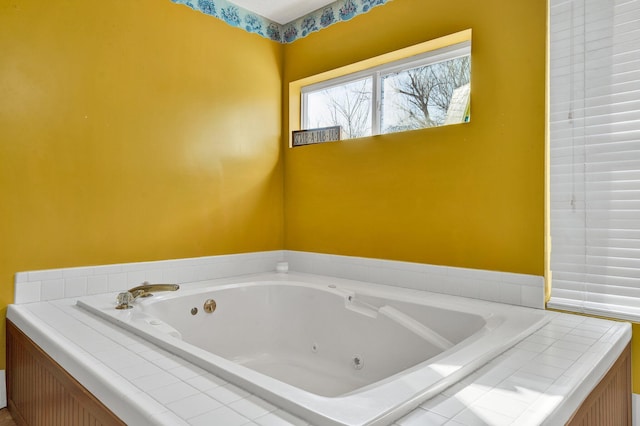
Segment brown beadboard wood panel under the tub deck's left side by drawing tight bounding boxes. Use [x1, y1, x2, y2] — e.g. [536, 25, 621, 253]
[7, 320, 125, 426]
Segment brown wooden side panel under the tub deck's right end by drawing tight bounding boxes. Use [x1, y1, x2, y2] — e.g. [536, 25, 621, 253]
[567, 344, 632, 426]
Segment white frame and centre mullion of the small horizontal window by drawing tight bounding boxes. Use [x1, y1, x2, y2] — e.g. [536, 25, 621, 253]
[300, 39, 471, 136]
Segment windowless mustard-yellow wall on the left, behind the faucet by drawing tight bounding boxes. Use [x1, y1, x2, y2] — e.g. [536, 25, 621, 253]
[0, 0, 283, 368]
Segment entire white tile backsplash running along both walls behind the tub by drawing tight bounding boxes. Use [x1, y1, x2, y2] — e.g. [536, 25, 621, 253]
[14, 250, 544, 309]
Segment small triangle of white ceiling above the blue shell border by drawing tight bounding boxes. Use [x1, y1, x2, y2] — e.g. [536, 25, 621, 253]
[231, 0, 335, 24]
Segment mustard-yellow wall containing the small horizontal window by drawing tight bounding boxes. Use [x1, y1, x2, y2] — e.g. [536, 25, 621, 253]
[283, 0, 546, 275]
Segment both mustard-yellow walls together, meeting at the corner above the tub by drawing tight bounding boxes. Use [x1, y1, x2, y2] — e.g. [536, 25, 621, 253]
[0, 0, 640, 400]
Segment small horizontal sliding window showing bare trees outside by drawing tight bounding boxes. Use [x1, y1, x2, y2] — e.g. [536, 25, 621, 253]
[301, 41, 471, 139]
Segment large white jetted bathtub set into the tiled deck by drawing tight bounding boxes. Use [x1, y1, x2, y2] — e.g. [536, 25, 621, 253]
[78, 274, 546, 425]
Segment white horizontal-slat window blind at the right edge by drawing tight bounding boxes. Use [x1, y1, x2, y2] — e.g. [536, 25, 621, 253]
[548, 0, 640, 321]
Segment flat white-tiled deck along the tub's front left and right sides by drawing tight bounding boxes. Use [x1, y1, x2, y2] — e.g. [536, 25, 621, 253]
[7, 282, 631, 426]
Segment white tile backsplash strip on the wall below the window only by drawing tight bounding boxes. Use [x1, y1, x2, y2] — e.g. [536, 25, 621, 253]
[284, 250, 544, 309]
